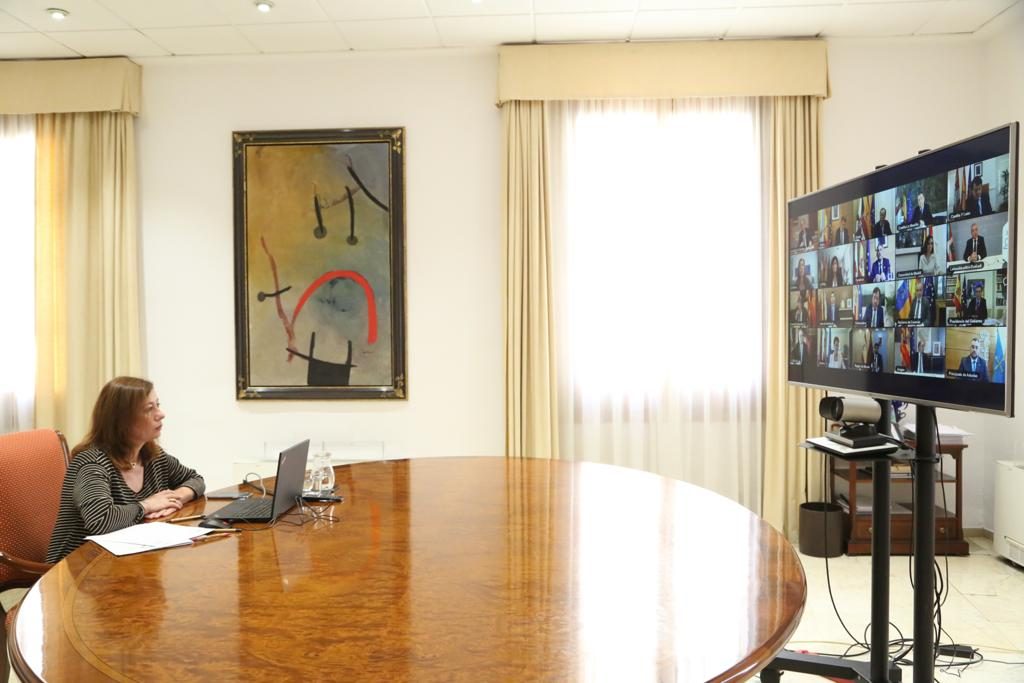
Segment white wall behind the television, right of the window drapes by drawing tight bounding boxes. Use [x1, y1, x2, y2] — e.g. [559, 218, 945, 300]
[822, 19, 1024, 528]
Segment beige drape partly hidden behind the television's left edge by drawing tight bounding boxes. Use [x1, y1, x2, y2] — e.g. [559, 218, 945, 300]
[762, 96, 823, 540]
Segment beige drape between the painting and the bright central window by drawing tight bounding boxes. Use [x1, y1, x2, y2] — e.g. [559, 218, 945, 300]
[502, 101, 558, 458]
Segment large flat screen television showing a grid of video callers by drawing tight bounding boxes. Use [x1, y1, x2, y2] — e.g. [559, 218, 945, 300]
[785, 123, 1018, 416]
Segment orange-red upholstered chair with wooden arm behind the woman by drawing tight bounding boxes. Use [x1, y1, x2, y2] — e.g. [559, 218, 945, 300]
[0, 429, 68, 681]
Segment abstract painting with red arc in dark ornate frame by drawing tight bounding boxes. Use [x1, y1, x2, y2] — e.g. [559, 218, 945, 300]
[233, 128, 407, 398]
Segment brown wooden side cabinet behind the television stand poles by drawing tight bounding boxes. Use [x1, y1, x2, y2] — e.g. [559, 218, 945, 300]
[828, 442, 969, 555]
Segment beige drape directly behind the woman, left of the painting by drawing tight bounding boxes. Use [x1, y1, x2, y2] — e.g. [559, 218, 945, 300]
[36, 112, 142, 442]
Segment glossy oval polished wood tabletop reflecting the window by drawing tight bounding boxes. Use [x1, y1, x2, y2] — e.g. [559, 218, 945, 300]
[10, 458, 806, 682]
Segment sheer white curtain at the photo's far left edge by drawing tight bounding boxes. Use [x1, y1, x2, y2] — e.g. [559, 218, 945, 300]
[0, 116, 36, 433]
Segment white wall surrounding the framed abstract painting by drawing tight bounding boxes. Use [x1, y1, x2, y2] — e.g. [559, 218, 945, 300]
[138, 50, 504, 485]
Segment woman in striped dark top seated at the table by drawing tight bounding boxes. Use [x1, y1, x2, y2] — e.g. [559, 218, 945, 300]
[46, 377, 206, 562]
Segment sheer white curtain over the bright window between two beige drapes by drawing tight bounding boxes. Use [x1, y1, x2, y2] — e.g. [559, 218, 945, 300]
[551, 98, 767, 511]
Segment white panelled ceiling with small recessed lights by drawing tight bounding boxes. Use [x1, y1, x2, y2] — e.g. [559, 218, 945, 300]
[0, 0, 1024, 59]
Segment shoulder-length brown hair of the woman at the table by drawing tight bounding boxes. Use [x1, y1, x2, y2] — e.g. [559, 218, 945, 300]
[72, 377, 160, 470]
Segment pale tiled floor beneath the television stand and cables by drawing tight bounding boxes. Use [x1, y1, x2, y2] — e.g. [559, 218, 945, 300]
[782, 538, 1024, 683]
